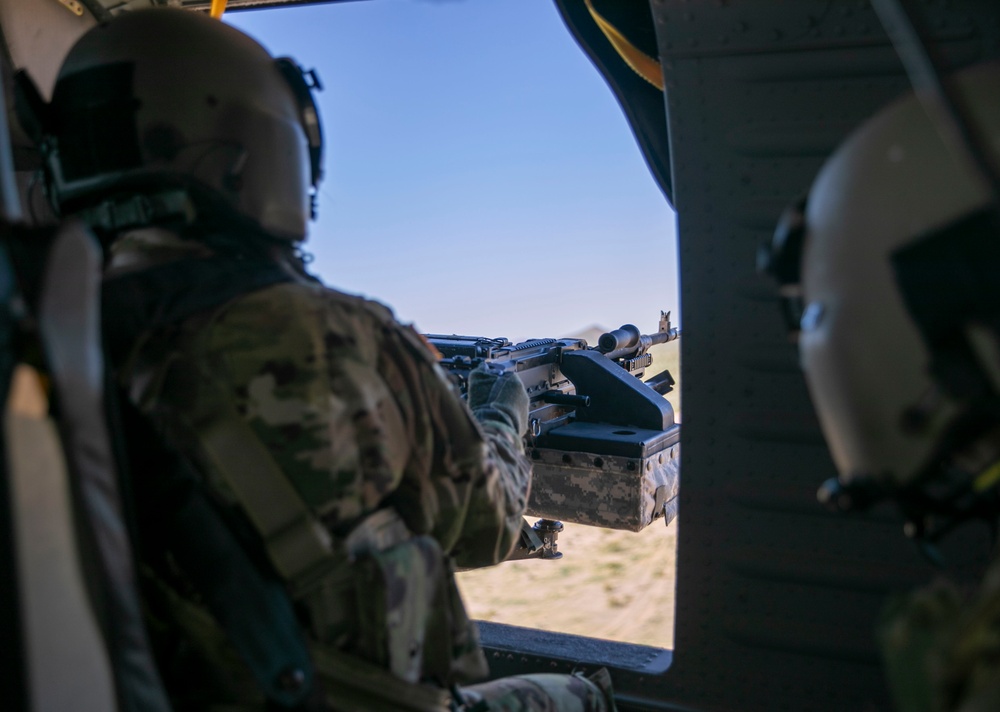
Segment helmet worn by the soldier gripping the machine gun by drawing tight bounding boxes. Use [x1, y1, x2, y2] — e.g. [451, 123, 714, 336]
[37, 8, 323, 241]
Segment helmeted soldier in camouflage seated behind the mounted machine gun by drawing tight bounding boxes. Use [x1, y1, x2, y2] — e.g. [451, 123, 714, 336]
[31, 9, 614, 712]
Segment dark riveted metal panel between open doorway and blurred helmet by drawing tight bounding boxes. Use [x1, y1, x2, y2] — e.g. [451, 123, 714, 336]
[640, 0, 1000, 710]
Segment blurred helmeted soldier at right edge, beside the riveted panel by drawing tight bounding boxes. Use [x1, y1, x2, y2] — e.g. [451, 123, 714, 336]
[773, 63, 1000, 712]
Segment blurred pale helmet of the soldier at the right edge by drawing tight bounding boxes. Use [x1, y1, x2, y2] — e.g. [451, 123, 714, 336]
[776, 63, 1000, 524]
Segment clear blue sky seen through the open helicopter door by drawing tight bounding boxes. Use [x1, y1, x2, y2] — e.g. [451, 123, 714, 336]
[230, 0, 679, 339]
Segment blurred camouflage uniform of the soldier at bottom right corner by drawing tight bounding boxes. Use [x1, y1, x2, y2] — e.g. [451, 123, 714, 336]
[879, 559, 1000, 712]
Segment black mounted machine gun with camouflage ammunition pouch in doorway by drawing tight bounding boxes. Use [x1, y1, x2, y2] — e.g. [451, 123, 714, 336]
[426, 312, 680, 558]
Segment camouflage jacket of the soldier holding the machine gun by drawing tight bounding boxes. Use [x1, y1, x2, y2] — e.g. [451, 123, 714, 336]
[106, 231, 530, 685]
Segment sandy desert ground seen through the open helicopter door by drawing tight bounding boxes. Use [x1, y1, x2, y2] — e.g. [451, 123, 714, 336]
[458, 334, 680, 648]
